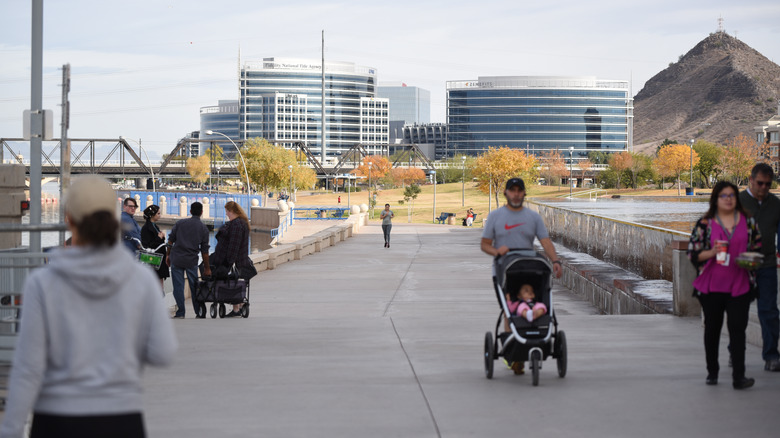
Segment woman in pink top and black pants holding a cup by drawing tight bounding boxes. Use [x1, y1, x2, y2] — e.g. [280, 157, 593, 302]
[688, 181, 761, 389]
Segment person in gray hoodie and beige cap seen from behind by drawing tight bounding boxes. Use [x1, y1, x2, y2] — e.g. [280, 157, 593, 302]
[0, 176, 177, 438]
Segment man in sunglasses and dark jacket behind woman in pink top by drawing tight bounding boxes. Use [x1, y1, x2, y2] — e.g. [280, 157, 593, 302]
[739, 163, 780, 371]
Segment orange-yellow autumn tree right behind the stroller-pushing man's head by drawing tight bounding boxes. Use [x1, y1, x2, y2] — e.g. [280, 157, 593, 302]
[469, 146, 538, 205]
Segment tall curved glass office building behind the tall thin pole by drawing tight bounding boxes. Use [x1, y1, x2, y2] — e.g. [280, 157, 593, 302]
[238, 58, 389, 156]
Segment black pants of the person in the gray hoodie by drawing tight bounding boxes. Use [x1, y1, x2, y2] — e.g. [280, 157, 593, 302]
[30, 412, 146, 438]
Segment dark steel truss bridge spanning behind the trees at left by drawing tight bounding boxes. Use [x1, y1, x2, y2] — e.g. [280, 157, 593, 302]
[0, 138, 434, 179]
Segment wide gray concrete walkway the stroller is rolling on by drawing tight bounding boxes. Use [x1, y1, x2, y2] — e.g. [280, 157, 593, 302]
[145, 224, 780, 438]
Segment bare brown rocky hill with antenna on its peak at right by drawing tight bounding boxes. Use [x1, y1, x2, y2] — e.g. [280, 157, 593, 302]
[634, 32, 780, 153]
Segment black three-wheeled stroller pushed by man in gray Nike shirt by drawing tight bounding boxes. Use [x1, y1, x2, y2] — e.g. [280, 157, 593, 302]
[485, 251, 566, 386]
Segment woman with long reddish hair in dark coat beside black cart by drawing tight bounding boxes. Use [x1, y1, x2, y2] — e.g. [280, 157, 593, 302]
[209, 201, 252, 317]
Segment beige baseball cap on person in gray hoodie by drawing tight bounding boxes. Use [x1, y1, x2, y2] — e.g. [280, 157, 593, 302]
[65, 175, 119, 222]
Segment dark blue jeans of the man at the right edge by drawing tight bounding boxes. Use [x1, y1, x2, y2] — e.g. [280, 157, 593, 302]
[756, 266, 780, 360]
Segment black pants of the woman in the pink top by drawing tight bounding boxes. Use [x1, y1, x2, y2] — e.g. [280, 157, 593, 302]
[699, 292, 750, 380]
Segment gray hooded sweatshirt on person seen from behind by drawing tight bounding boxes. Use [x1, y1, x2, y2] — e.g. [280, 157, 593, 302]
[0, 244, 177, 438]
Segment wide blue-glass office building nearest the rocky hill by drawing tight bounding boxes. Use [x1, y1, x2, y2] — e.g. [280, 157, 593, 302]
[445, 76, 634, 158]
